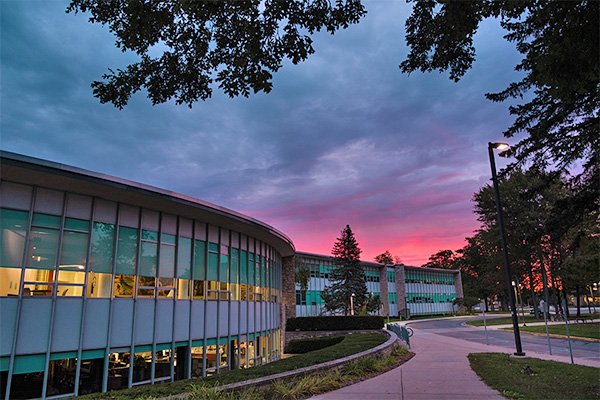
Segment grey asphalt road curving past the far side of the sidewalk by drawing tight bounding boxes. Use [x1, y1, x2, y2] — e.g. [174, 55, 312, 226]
[410, 317, 600, 362]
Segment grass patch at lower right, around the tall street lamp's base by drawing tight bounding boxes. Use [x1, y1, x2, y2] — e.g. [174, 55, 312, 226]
[469, 353, 600, 400]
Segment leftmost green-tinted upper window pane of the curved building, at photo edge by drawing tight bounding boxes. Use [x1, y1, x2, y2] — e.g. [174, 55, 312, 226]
[0, 209, 29, 268]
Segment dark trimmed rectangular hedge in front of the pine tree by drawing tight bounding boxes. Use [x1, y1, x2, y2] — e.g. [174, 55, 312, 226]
[286, 315, 384, 331]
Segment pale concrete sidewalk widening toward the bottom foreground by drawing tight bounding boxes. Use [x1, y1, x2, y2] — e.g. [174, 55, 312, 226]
[312, 329, 600, 400]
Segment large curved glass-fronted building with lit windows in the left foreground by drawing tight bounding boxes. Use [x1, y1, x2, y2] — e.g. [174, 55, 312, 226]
[0, 152, 294, 398]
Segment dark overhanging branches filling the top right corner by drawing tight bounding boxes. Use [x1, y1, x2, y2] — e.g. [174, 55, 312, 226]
[400, 0, 600, 196]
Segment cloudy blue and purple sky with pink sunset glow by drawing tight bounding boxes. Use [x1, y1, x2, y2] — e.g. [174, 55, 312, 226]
[0, 0, 520, 265]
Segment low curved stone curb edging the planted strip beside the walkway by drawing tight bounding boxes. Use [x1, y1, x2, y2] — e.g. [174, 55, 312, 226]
[163, 329, 404, 400]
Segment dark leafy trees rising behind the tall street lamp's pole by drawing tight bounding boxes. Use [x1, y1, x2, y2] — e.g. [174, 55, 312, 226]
[426, 169, 600, 314]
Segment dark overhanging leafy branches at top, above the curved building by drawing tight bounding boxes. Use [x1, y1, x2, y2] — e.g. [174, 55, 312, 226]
[67, 0, 366, 108]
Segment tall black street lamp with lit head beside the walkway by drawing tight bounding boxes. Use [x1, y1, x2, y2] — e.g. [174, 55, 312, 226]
[488, 142, 525, 356]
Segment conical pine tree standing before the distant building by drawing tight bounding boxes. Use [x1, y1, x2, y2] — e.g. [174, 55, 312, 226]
[321, 225, 368, 315]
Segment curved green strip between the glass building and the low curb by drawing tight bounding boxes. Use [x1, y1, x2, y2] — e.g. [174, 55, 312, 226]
[79, 332, 387, 400]
